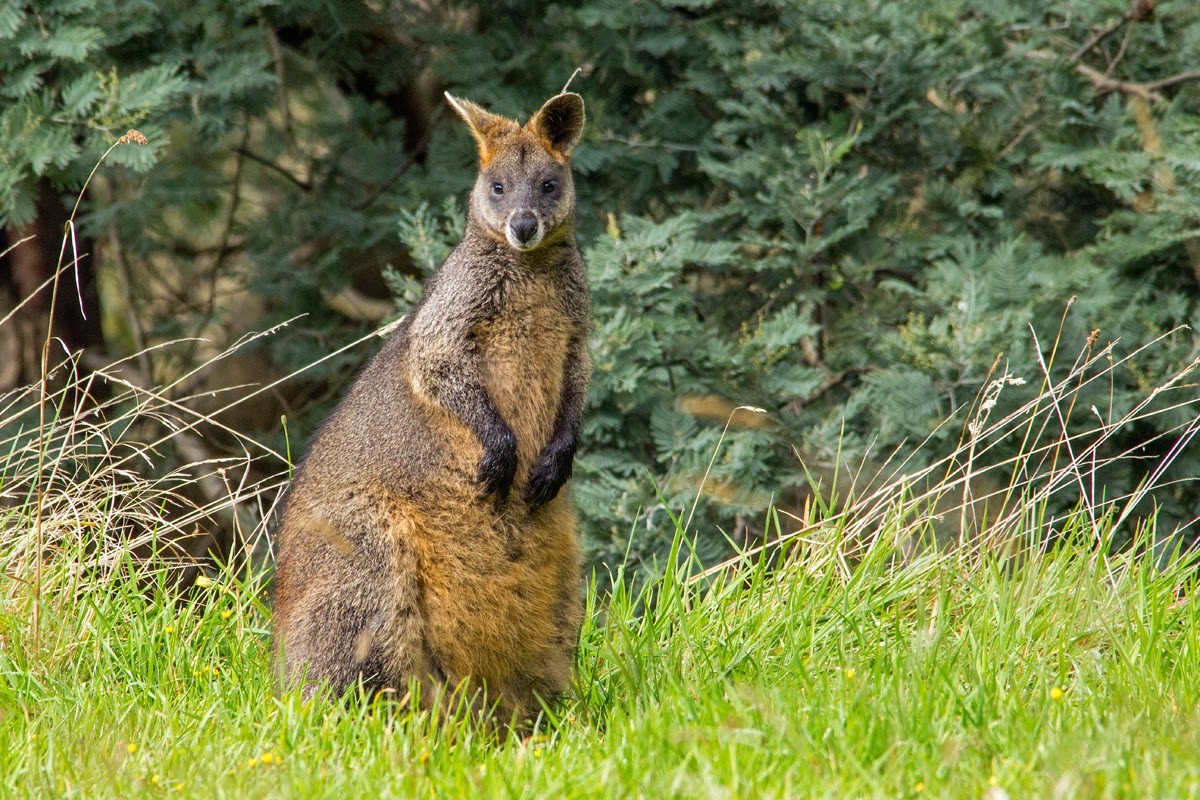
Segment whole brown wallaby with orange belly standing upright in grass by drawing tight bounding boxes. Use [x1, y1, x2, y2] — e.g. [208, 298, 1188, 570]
[274, 94, 590, 721]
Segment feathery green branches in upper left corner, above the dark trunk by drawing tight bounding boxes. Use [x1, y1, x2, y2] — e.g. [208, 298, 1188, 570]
[0, 0, 274, 224]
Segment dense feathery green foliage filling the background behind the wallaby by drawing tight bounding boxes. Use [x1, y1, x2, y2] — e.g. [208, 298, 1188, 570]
[0, 0, 1200, 563]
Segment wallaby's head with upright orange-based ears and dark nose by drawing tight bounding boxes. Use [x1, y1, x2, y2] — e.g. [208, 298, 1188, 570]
[446, 92, 583, 251]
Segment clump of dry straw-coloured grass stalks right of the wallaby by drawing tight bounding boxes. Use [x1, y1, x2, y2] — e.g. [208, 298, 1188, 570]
[696, 316, 1200, 581]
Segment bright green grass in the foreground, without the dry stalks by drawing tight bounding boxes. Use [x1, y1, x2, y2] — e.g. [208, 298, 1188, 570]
[0, 525, 1200, 798]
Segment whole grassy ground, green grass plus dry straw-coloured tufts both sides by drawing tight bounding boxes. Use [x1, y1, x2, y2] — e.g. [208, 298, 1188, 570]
[0, 321, 1200, 800]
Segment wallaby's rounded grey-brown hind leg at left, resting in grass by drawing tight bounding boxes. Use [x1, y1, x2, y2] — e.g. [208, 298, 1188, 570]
[275, 506, 439, 702]
